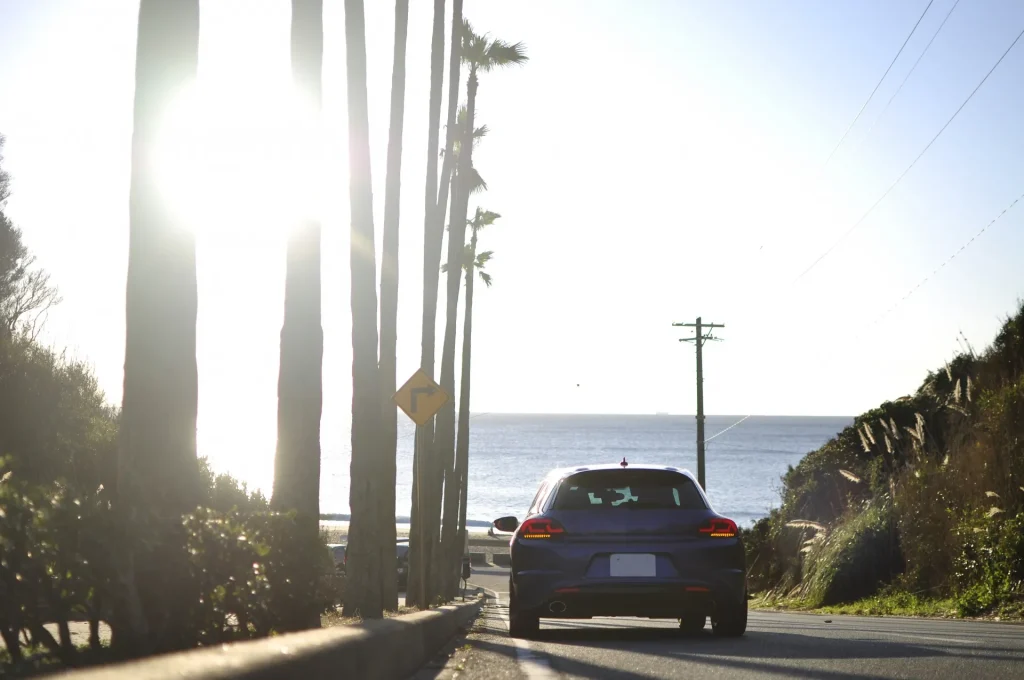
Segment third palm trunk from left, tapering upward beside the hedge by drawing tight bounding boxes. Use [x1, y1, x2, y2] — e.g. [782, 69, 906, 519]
[344, 0, 385, 619]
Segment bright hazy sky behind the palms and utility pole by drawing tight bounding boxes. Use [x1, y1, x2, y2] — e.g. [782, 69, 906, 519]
[0, 0, 1024, 493]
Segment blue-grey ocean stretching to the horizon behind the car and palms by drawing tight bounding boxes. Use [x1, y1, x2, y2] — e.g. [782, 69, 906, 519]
[321, 414, 853, 526]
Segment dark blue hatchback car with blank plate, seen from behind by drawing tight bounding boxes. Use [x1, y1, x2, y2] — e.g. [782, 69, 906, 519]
[494, 459, 748, 638]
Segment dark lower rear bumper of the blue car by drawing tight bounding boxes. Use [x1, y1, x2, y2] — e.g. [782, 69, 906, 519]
[513, 569, 746, 619]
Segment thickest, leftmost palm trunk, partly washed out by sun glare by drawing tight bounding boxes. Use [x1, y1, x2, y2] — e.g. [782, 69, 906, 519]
[114, 0, 200, 651]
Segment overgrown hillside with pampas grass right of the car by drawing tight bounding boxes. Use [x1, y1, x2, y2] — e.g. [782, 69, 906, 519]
[745, 304, 1024, 617]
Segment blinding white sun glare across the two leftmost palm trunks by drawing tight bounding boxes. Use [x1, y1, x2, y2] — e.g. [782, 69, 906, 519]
[155, 77, 325, 238]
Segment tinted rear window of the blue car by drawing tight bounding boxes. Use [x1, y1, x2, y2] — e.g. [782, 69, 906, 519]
[552, 470, 708, 510]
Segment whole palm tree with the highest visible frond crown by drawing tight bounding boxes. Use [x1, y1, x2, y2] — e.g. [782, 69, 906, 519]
[434, 19, 528, 596]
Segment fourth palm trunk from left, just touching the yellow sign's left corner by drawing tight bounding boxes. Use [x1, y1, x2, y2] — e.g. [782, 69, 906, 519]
[377, 0, 409, 610]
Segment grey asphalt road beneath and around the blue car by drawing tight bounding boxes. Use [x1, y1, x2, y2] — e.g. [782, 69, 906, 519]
[458, 567, 1024, 680]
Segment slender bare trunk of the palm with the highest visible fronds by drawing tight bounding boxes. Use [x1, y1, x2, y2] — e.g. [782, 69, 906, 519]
[434, 69, 476, 599]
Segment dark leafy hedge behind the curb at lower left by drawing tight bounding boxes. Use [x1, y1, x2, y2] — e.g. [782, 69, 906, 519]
[0, 456, 343, 666]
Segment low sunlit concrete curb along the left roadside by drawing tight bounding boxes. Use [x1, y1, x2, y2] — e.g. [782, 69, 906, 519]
[53, 597, 483, 680]
